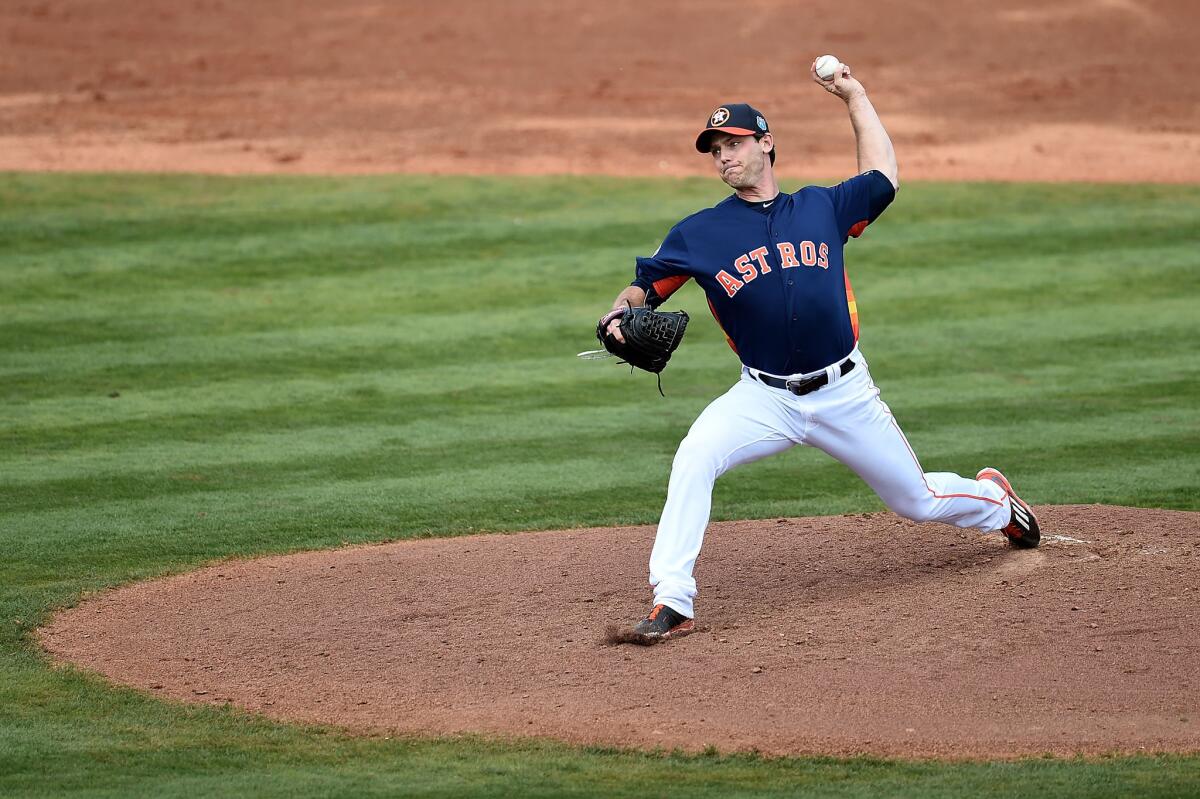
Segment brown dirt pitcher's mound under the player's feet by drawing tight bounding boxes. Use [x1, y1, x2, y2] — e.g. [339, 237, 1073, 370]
[41, 506, 1200, 757]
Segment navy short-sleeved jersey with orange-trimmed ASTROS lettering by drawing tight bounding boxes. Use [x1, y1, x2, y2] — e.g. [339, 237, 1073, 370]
[634, 170, 895, 376]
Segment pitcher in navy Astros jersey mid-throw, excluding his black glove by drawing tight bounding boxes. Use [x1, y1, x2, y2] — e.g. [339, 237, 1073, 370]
[598, 61, 1040, 644]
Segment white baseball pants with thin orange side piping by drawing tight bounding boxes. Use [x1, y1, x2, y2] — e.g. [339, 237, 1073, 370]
[650, 350, 1012, 617]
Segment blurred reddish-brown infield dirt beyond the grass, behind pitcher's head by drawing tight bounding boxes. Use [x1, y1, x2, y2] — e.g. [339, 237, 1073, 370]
[0, 0, 1200, 182]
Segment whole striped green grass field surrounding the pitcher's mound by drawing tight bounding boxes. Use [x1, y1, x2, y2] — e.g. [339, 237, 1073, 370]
[0, 174, 1200, 798]
